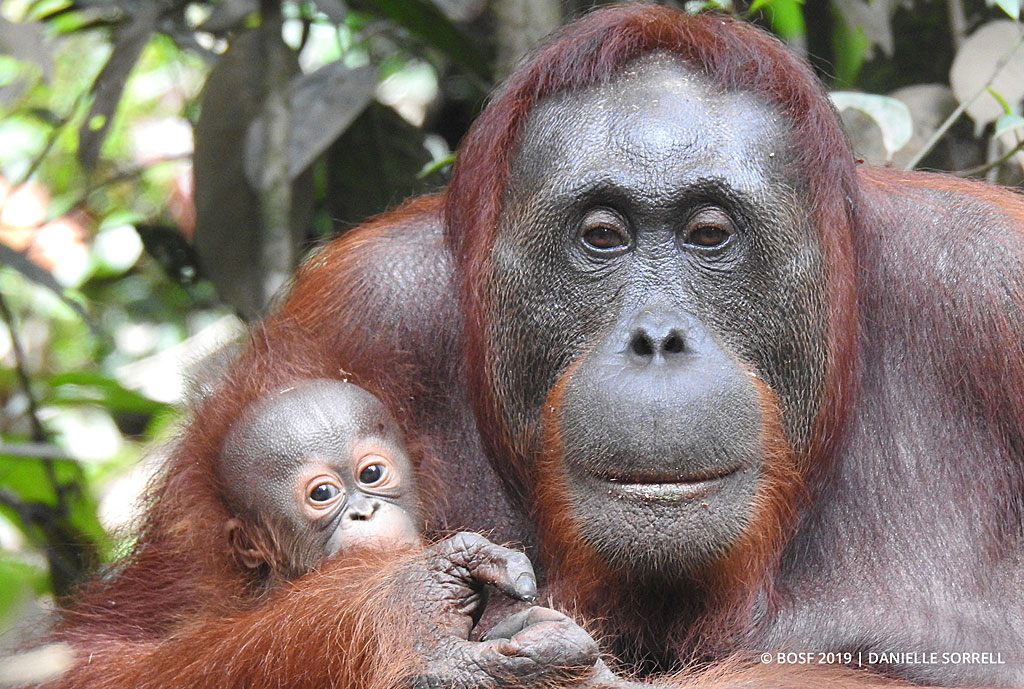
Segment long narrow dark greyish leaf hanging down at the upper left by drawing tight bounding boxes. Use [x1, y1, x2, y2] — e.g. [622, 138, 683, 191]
[78, 1, 164, 170]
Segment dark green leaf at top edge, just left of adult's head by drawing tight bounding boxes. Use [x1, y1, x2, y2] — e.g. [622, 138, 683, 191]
[352, 0, 490, 79]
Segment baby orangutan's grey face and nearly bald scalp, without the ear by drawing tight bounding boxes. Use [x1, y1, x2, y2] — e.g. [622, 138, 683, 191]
[218, 380, 420, 563]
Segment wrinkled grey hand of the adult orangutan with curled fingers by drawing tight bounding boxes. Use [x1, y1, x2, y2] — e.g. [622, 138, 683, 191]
[398, 533, 598, 689]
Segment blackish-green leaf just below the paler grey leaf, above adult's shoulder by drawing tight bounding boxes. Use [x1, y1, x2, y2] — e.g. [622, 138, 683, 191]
[328, 102, 439, 228]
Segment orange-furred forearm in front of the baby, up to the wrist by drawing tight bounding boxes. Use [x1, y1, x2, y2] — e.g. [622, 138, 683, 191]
[52, 552, 422, 689]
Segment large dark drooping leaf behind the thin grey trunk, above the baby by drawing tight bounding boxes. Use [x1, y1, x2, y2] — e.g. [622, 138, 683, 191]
[193, 31, 312, 320]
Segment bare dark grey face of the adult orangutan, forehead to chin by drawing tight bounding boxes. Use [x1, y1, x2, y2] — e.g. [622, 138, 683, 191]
[486, 53, 827, 578]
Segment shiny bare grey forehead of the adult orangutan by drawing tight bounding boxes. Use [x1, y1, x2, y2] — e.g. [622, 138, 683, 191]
[511, 53, 790, 198]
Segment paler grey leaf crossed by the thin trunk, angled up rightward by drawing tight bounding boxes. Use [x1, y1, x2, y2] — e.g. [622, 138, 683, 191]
[246, 60, 377, 187]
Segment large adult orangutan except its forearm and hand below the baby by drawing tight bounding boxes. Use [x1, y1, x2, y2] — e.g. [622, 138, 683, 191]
[49, 5, 1024, 686]
